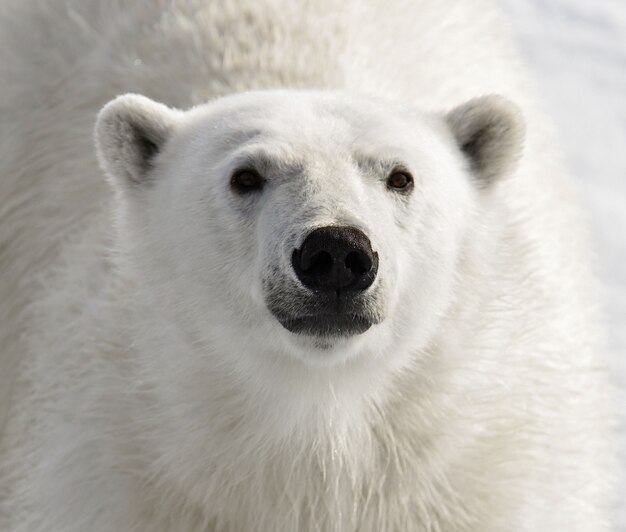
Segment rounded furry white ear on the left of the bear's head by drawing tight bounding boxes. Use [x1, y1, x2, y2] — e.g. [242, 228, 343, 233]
[95, 94, 177, 186]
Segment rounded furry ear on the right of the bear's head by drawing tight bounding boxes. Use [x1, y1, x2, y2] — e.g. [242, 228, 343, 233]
[446, 95, 526, 185]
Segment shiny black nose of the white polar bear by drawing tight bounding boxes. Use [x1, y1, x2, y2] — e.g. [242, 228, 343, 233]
[291, 226, 378, 293]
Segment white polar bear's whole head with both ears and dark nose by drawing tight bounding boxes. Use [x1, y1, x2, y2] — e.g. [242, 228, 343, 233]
[96, 91, 523, 365]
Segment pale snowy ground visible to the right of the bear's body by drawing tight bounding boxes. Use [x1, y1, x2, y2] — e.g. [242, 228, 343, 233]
[502, 0, 626, 532]
